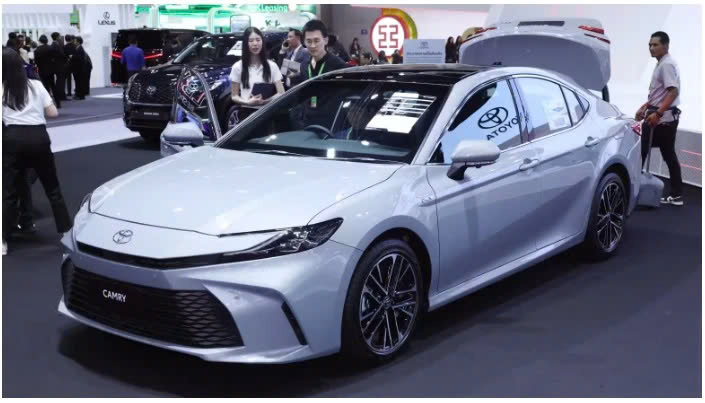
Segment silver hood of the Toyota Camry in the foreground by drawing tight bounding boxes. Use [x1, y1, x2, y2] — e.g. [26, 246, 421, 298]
[91, 146, 401, 235]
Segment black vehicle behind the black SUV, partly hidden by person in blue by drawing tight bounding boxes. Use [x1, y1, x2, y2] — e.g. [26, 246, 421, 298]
[110, 28, 208, 85]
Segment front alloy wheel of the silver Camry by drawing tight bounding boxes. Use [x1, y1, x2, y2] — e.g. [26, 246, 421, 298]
[359, 253, 420, 355]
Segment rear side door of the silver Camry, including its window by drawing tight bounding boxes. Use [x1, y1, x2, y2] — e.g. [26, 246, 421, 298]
[515, 76, 602, 248]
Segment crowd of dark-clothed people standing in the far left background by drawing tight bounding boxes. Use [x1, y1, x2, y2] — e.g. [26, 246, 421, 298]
[5, 32, 93, 108]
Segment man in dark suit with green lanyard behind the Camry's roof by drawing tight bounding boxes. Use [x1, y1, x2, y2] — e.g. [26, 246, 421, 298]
[291, 20, 348, 88]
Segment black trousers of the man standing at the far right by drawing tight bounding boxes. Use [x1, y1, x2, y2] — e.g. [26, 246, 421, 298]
[641, 121, 683, 197]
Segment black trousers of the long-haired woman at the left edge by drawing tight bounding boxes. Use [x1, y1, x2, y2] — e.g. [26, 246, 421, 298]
[2, 125, 72, 240]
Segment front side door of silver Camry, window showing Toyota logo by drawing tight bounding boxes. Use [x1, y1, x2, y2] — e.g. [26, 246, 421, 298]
[428, 80, 540, 291]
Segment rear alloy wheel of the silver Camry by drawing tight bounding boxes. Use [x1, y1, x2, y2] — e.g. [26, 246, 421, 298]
[596, 182, 626, 252]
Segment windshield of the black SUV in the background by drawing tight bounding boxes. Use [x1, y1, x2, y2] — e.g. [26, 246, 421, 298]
[174, 36, 242, 65]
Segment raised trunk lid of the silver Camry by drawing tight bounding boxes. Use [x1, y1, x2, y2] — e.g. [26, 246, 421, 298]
[460, 18, 611, 101]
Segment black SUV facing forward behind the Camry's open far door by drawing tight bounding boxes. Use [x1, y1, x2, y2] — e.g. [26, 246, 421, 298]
[123, 31, 287, 142]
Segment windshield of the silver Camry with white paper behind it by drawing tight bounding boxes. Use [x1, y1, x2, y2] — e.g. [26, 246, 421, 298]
[219, 80, 449, 163]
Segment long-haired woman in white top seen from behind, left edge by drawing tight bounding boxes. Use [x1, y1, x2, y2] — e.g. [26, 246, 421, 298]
[2, 48, 72, 255]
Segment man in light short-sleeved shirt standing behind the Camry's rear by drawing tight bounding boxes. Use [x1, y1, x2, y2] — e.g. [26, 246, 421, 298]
[635, 31, 683, 206]
